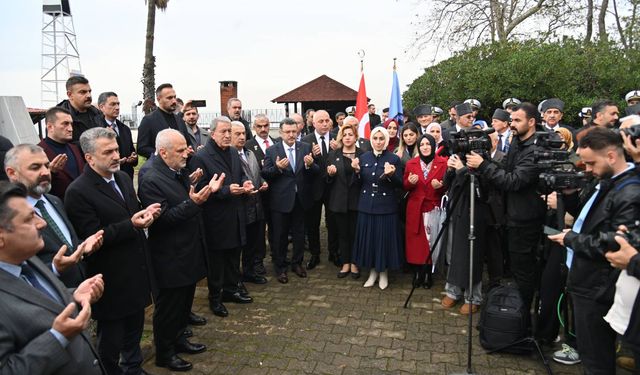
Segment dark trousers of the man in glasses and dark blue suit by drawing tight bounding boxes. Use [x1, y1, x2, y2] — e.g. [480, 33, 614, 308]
[271, 198, 305, 275]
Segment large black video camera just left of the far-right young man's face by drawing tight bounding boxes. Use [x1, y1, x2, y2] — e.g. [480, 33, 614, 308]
[533, 131, 589, 194]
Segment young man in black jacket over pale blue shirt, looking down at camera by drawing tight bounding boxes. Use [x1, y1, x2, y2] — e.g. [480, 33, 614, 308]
[549, 128, 640, 374]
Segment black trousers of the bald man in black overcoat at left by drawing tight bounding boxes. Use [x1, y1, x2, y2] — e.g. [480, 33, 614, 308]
[153, 284, 195, 360]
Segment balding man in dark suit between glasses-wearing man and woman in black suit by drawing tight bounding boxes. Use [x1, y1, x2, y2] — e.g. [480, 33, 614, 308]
[302, 110, 342, 270]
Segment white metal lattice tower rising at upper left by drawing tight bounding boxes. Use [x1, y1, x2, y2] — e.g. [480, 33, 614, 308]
[40, 0, 82, 107]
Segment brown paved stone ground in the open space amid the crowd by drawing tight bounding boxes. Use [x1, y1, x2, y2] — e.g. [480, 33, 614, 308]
[136, 255, 600, 375]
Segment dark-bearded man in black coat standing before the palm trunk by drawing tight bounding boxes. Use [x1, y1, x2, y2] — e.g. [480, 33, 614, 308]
[138, 83, 187, 159]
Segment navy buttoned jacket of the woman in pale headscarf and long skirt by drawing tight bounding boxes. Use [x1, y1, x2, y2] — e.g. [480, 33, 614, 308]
[358, 151, 404, 215]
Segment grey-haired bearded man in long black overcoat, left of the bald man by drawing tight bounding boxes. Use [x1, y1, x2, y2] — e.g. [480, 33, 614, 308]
[65, 127, 160, 374]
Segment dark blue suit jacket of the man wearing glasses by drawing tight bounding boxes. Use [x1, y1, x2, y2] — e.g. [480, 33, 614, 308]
[262, 141, 320, 213]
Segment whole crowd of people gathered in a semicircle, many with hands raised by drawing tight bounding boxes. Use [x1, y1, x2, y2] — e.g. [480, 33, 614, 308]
[0, 77, 640, 374]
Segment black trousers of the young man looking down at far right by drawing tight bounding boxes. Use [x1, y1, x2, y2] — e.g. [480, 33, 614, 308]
[572, 295, 616, 375]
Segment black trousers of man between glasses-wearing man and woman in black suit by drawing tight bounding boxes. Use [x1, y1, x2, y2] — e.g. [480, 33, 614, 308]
[304, 197, 339, 256]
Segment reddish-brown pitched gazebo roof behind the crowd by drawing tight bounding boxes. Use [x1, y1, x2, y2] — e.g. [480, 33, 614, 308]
[272, 74, 368, 103]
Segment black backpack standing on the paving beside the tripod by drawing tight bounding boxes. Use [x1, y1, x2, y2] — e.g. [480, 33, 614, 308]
[477, 285, 532, 354]
